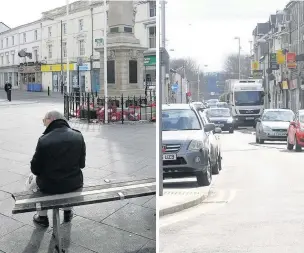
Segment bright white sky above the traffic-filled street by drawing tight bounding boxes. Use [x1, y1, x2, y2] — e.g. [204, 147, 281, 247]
[166, 0, 289, 71]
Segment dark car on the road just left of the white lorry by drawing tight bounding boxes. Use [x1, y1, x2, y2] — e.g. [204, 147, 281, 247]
[205, 108, 234, 133]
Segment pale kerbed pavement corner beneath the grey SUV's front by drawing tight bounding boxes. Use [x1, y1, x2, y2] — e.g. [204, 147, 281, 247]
[158, 176, 216, 217]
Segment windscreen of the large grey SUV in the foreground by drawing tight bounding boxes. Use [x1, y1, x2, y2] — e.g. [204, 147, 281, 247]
[162, 109, 202, 131]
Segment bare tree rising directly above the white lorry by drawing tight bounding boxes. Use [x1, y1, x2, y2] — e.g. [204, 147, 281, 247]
[224, 54, 251, 79]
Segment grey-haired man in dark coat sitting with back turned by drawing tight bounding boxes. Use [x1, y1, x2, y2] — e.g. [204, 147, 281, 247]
[27, 111, 86, 227]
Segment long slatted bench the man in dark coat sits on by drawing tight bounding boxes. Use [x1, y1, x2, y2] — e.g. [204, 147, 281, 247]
[12, 178, 156, 253]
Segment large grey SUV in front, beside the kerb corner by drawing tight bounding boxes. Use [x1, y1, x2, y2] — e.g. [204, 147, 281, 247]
[162, 104, 220, 186]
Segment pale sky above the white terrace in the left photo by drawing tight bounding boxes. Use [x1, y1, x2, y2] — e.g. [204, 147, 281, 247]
[0, 0, 75, 28]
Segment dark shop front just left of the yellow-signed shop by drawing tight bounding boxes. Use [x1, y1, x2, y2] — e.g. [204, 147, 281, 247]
[18, 62, 42, 90]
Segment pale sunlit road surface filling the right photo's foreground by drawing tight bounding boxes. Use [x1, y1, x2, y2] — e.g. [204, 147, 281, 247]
[160, 131, 304, 253]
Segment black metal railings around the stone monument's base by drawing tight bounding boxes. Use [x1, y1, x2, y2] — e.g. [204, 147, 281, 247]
[64, 91, 156, 124]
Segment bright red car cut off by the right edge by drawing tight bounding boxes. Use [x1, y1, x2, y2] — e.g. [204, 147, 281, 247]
[287, 110, 304, 152]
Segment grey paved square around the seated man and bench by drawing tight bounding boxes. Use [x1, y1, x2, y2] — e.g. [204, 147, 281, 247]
[0, 92, 156, 253]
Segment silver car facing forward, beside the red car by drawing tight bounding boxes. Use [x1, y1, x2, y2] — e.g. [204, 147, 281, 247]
[255, 109, 294, 144]
